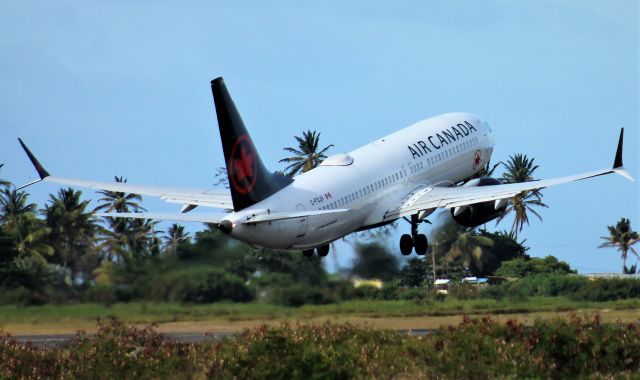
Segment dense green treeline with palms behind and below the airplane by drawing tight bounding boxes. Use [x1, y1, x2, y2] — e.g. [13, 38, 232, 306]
[0, 177, 637, 306]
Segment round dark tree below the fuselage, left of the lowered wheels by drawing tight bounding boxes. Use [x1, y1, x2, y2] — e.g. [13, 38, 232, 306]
[350, 242, 398, 281]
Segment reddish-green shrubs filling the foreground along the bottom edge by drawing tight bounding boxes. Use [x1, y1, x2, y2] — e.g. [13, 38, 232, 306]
[0, 316, 640, 379]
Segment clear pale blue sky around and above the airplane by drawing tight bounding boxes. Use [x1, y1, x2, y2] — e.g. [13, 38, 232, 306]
[0, 0, 640, 272]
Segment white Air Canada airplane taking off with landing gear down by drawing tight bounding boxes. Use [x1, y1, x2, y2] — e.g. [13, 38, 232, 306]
[18, 77, 634, 257]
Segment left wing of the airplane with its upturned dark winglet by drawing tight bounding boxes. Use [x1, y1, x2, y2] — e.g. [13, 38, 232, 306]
[18, 139, 233, 209]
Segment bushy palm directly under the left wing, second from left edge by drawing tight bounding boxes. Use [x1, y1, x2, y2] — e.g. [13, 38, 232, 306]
[40, 188, 100, 280]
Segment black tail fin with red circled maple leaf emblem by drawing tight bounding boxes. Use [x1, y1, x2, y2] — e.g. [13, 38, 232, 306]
[211, 77, 292, 211]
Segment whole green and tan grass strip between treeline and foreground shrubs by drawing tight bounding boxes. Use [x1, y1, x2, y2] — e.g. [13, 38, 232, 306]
[0, 297, 640, 334]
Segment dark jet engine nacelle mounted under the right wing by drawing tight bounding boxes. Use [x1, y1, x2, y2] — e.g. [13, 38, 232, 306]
[451, 177, 507, 227]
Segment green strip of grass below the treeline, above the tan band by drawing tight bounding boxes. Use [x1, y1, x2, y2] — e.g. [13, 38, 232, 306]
[0, 292, 640, 328]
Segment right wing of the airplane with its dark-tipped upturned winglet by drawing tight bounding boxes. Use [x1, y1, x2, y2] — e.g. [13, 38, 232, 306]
[384, 129, 633, 221]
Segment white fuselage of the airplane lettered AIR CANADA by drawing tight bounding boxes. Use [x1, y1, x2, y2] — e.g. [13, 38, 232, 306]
[224, 113, 493, 249]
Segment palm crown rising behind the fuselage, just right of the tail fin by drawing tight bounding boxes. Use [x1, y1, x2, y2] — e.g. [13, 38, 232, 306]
[280, 130, 333, 177]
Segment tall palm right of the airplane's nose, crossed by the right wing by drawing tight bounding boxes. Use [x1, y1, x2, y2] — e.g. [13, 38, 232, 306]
[496, 153, 549, 239]
